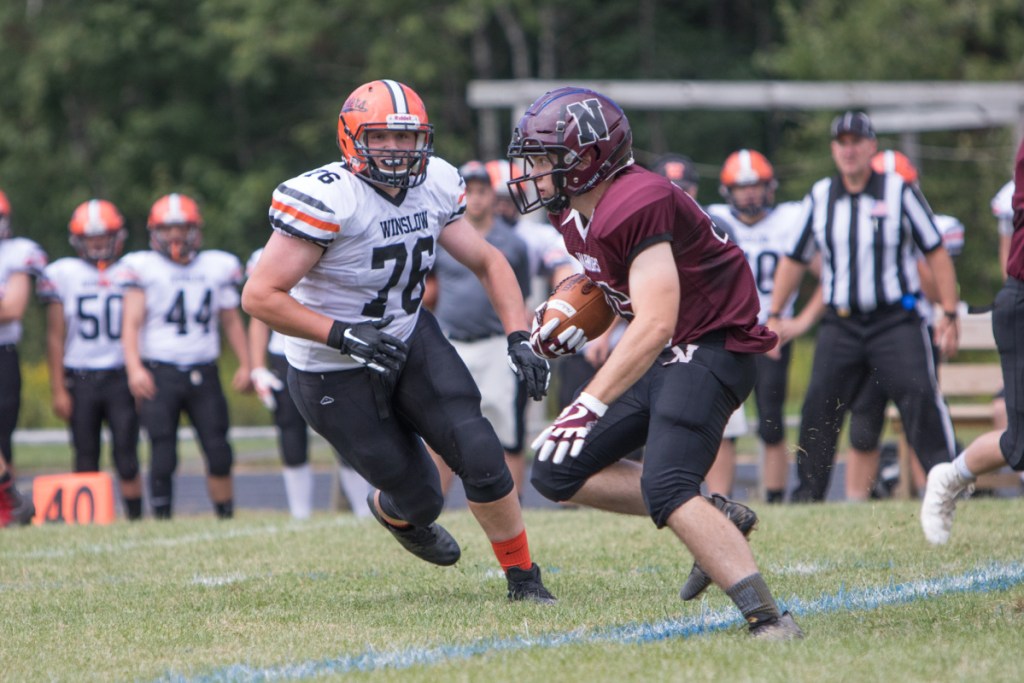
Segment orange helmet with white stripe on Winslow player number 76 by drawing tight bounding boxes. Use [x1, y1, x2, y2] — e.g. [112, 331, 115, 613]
[338, 80, 434, 187]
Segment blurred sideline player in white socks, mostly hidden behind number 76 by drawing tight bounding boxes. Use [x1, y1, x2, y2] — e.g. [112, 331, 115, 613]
[246, 249, 370, 519]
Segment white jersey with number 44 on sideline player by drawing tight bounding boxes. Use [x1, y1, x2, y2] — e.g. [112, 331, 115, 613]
[115, 249, 242, 366]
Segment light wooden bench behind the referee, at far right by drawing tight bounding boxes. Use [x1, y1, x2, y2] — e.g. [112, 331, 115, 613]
[887, 304, 1021, 498]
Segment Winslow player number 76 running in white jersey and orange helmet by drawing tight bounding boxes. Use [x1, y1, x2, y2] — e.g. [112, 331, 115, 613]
[243, 80, 554, 602]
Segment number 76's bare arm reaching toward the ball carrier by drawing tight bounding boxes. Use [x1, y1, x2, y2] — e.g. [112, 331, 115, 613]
[438, 218, 527, 335]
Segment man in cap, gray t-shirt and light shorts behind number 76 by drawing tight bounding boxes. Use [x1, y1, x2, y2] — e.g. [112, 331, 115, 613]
[431, 161, 530, 491]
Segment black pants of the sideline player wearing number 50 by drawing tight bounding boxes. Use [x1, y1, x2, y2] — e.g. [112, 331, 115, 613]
[65, 368, 138, 481]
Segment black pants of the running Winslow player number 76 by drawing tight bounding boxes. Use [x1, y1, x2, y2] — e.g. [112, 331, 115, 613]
[288, 311, 512, 523]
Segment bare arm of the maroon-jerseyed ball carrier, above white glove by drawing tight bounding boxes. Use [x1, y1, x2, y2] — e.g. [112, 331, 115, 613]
[584, 242, 680, 404]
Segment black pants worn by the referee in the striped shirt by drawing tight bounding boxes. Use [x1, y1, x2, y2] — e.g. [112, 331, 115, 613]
[792, 307, 955, 503]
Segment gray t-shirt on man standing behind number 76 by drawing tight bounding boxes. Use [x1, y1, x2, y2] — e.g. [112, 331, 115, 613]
[434, 218, 529, 341]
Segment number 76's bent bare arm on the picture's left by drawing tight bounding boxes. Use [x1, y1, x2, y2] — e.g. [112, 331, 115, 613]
[242, 232, 334, 344]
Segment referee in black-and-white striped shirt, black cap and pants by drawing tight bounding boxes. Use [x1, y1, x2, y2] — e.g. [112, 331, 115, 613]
[768, 112, 958, 503]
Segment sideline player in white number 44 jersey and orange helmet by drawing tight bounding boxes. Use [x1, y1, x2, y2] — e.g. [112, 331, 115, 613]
[116, 194, 252, 519]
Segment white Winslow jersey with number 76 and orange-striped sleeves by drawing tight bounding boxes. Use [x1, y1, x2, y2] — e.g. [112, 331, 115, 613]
[270, 157, 466, 372]
